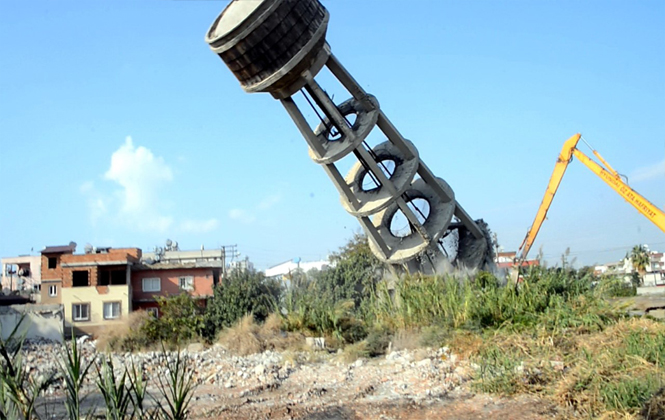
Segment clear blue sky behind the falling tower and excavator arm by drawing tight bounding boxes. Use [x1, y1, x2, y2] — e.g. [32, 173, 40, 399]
[0, 0, 665, 268]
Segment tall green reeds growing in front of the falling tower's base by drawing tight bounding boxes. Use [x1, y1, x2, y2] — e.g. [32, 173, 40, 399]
[366, 269, 616, 331]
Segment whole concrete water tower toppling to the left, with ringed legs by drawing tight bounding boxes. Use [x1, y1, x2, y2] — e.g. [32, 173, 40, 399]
[206, 0, 492, 273]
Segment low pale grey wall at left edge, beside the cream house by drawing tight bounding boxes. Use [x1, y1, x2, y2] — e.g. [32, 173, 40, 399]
[0, 305, 65, 341]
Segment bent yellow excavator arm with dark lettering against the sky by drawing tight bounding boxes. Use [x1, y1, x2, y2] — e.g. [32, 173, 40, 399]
[516, 134, 665, 268]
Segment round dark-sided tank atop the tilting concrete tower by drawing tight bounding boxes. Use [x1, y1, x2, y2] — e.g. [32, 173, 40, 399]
[206, 0, 329, 98]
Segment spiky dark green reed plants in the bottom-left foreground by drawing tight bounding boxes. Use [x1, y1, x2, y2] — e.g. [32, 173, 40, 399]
[0, 319, 196, 420]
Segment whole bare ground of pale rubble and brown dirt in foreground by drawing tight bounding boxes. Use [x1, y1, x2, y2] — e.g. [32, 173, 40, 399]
[25, 340, 574, 420]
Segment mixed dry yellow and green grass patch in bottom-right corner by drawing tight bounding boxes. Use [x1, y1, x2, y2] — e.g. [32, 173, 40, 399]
[470, 319, 665, 420]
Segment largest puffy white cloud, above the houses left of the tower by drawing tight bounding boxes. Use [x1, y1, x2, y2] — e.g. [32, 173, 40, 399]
[79, 137, 219, 233]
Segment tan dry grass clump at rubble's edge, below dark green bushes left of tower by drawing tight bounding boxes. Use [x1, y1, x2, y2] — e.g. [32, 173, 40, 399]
[219, 314, 305, 356]
